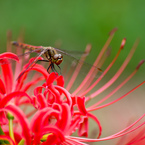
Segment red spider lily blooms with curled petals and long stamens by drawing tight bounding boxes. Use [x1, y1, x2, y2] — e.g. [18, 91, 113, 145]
[0, 30, 145, 145]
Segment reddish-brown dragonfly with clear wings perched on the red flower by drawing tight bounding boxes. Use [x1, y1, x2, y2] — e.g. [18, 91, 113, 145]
[12, 41, 102, 79]
